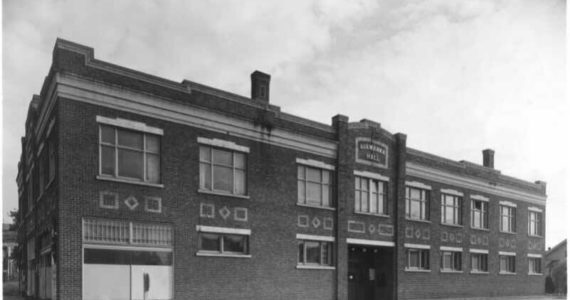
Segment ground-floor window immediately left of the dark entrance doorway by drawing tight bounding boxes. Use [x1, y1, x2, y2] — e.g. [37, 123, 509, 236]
[297, 240, 333, 266]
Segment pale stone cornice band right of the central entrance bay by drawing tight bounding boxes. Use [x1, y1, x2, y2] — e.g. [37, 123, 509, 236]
[406, 162, 546, 205]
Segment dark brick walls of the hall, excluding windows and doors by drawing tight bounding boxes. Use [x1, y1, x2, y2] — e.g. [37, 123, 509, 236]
[18, 40, 546, 299]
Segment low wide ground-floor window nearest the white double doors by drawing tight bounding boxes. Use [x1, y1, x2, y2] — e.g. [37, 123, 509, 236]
[200, 232, 249, 254]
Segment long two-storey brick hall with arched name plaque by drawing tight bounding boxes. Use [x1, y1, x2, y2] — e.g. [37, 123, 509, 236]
[17, 40, 546, 299]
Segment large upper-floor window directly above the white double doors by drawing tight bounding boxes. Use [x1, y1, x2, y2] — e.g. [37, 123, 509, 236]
[99, 125, 160, 183]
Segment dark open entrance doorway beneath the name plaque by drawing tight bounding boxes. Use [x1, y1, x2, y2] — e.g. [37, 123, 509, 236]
[348, 245, 394, 300]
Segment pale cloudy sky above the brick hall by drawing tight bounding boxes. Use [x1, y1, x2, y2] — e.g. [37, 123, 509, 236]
[2, 0, 570, 246]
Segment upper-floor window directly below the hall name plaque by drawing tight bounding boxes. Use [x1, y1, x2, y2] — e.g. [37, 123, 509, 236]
[354, 176, 387, 215]
